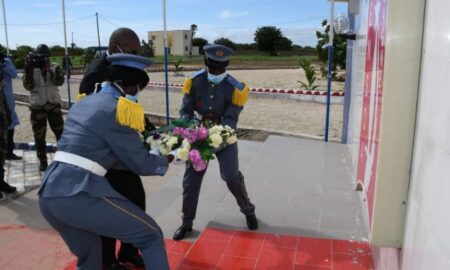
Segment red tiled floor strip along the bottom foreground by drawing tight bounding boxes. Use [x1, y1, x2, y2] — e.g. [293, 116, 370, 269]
[0, 224, 373, 270]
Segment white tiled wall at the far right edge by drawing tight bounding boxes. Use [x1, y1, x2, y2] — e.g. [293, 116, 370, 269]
[402, 0, 450, 270]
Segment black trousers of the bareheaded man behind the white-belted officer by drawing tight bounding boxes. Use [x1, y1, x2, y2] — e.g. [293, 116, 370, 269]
[102, 170, 145, 264]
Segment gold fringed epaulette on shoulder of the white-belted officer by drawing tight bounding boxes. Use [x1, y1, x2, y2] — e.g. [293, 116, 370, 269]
[116, 97, 145, 132]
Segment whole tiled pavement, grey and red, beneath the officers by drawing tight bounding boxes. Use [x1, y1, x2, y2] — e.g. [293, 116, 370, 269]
[0, 136, 373, 270]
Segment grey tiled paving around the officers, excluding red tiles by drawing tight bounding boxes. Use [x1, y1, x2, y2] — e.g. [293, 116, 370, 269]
[0, 136, 367, 241]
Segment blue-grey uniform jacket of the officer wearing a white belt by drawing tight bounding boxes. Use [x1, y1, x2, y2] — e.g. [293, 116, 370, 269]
[39, 86, 168, 198]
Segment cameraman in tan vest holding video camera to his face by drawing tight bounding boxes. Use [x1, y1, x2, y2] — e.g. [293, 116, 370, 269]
[23, 44, 64, 171]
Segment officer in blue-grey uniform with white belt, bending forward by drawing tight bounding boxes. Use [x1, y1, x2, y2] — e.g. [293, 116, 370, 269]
[39, 54, 173, 270]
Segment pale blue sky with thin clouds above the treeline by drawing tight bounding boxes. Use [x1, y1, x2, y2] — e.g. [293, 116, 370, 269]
[0, 0, 347, 48]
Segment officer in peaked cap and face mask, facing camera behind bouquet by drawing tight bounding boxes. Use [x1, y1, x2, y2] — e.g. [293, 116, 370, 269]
[173, 45, 258, 240]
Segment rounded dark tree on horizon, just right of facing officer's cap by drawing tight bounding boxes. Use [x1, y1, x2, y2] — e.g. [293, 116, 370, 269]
[254, 26, 292, 55]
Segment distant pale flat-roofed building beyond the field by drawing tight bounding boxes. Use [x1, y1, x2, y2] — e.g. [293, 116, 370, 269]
[148, 30, 199, 56]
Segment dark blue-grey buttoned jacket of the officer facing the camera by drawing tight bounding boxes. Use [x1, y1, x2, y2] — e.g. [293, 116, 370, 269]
[180, 69, 245, 129]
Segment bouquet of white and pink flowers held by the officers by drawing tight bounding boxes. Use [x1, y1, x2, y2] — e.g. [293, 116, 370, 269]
[145, 119, 237, 172]
